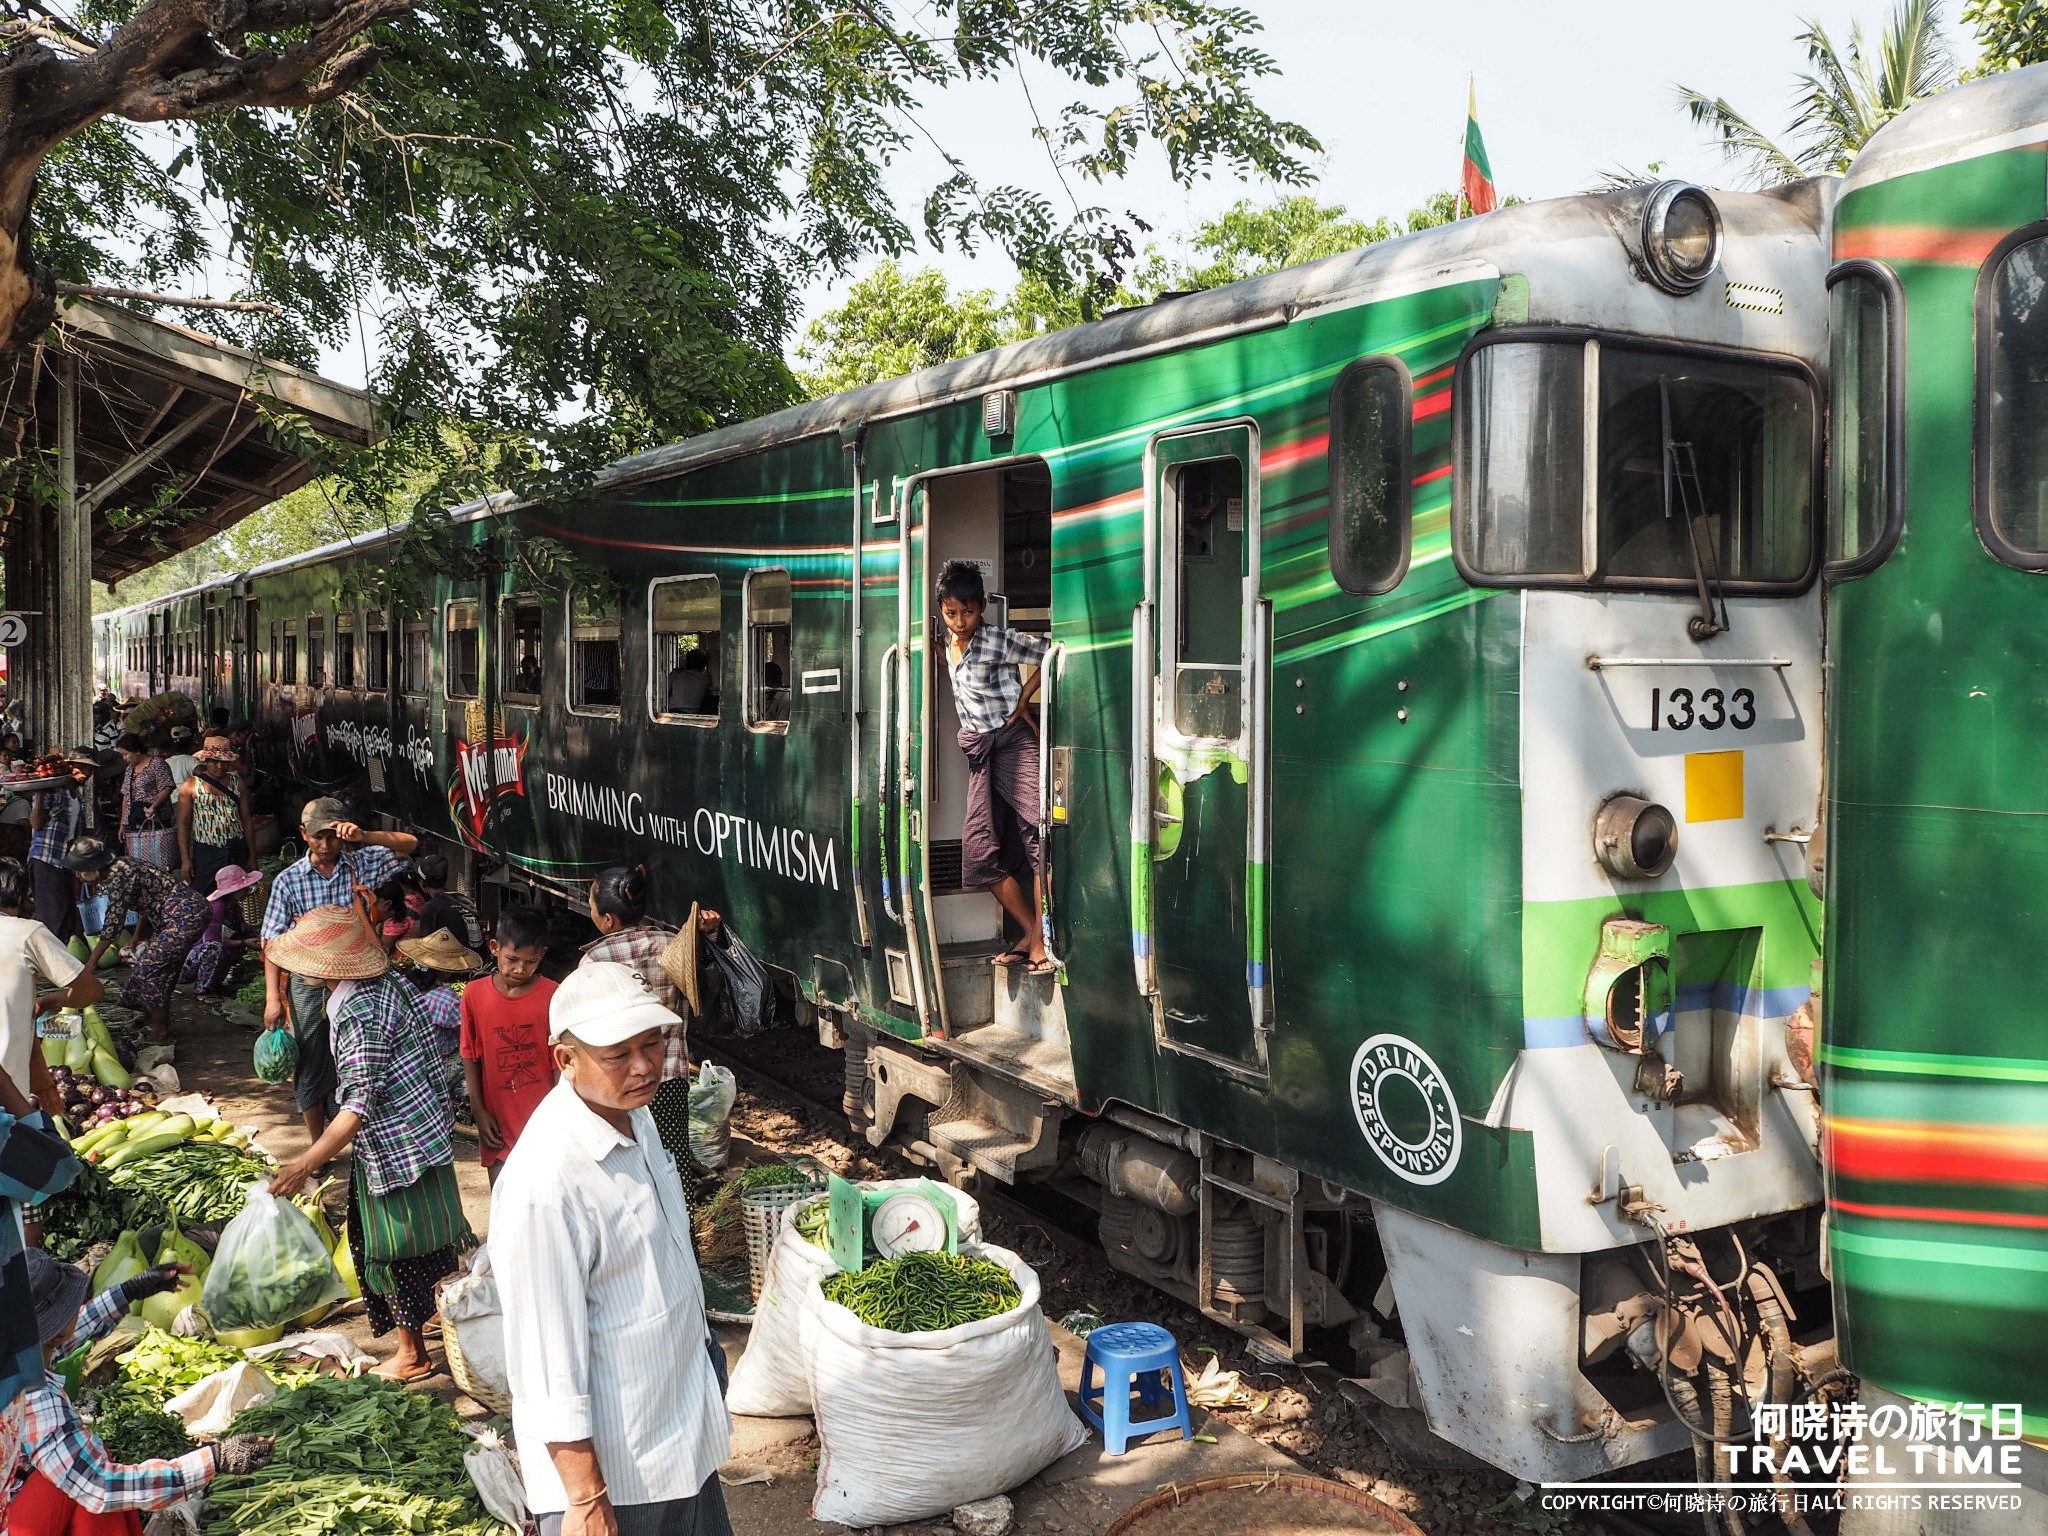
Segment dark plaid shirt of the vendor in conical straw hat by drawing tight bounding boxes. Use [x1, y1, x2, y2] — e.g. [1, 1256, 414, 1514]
[328, 971, 455, 1194]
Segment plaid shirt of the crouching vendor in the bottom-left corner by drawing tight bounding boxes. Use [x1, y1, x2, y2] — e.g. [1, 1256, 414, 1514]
[0, 1286, 213, 1516]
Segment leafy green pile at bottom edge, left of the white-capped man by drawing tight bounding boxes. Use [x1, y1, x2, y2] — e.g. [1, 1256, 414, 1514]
[205, 1376, 508, 1536]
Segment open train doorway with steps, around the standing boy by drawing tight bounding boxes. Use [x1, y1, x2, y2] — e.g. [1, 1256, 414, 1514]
[889, 459, 1073, 1100]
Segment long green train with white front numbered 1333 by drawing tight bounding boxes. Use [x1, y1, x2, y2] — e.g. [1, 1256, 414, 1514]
[98, 182, 1829, 1479]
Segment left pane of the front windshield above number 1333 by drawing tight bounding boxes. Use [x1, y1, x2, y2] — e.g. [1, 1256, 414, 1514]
[1458, 342, 1593, 580]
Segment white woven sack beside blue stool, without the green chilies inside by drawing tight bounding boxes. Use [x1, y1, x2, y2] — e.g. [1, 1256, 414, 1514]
[805, 1243, 1087, 1526]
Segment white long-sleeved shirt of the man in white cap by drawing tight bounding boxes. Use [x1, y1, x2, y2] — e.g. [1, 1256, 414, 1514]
[492, 1077, 733, 1513]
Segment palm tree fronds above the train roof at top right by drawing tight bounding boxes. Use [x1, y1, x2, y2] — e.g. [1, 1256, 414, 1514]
[1675, 0, 1956, 186]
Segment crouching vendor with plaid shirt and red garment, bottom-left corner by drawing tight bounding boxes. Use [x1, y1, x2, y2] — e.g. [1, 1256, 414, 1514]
[0, 1249, 272, 1536]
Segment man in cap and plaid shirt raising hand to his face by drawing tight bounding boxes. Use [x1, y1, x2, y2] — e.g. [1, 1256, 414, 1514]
[260, 798, 420, 1141]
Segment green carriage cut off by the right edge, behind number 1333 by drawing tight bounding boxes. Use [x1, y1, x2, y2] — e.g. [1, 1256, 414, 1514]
[1821, 68, 2048, 1532]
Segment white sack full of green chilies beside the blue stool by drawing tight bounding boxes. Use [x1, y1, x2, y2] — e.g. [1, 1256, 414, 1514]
[805, 1243, 1087, 1526]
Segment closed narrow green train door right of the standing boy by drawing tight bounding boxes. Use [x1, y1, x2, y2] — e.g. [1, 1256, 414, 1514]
[1130, 422, 1272, 1081]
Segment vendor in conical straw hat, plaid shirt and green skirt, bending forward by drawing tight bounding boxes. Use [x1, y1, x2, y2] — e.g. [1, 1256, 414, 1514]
[270, 905, 475, 1380]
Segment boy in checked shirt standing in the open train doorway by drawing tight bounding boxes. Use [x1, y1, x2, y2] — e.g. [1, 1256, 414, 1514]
[938, 559, 1053, 977]
